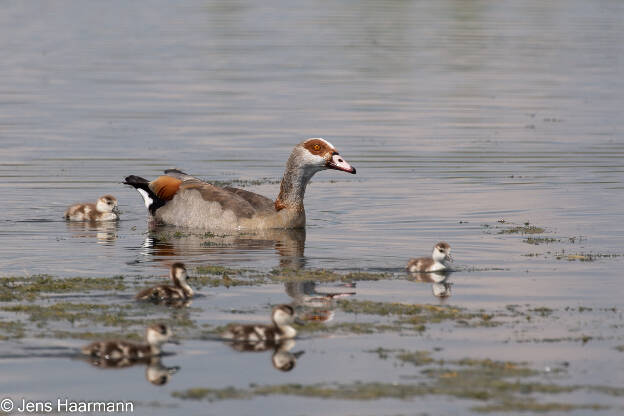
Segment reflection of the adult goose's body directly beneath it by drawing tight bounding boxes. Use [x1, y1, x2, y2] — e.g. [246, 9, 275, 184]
[141, 225, 306, 270]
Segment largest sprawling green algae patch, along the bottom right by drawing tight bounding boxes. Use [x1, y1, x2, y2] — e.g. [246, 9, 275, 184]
[172, 348, 622, 413]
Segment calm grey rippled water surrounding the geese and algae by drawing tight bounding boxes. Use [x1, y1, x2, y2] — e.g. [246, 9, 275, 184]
[0, 0, 624, 415]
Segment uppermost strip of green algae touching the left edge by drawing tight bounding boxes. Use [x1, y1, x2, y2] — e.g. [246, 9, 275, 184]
[0, 275, 127, 302]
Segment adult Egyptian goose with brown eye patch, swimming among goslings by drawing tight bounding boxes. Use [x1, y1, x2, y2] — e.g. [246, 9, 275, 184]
[124, 139, 355, 230]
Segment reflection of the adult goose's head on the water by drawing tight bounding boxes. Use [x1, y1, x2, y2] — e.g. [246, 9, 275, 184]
[284, 280, 356, 322]
